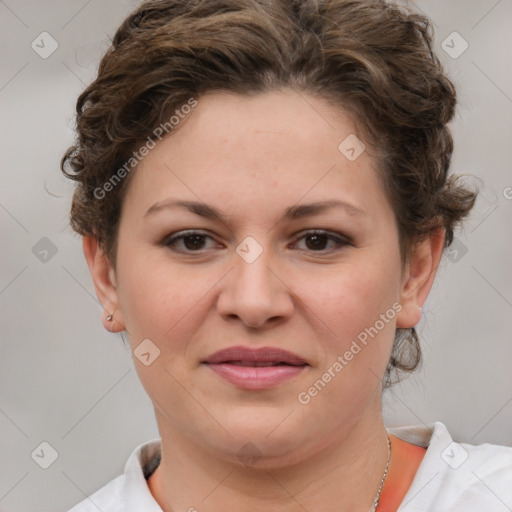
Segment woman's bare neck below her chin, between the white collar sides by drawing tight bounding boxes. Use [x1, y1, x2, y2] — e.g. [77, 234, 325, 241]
[148, 410, 388, 512]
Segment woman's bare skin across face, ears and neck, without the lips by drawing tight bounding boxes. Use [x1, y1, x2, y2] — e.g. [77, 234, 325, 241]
[83, 89, 444, 512]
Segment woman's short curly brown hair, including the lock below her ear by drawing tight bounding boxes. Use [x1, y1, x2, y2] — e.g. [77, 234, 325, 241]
[61, 0, 476, 386]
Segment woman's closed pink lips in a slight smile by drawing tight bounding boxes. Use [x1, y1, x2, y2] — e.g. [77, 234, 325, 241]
[204, 346, 309, 389]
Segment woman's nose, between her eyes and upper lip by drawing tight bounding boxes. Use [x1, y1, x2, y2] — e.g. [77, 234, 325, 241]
[217, 242, 294, 328]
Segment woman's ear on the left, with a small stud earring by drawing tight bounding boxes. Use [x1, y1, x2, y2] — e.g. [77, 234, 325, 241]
[82, 235, 126, 332]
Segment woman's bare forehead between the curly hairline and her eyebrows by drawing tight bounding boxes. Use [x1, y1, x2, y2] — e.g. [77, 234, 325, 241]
[120, 90, 390, 224]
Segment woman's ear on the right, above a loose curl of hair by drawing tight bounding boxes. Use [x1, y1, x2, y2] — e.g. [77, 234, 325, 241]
[396, 228, 446, 329]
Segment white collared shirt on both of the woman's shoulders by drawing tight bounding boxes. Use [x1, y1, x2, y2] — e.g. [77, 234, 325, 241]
[68, 421, 512, 512]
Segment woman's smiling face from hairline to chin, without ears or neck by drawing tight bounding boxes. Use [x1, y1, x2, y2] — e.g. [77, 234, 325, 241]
[91, 90, 428, 463]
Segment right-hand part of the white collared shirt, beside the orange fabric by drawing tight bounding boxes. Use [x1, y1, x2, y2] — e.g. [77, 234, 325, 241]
[390, 422, 512, 512]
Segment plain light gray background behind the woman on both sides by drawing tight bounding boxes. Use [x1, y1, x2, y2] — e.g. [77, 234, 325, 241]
[0, 0, 512, 512]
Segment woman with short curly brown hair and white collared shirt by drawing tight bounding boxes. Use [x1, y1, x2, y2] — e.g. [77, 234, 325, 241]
[63, 0, 512, 512]
